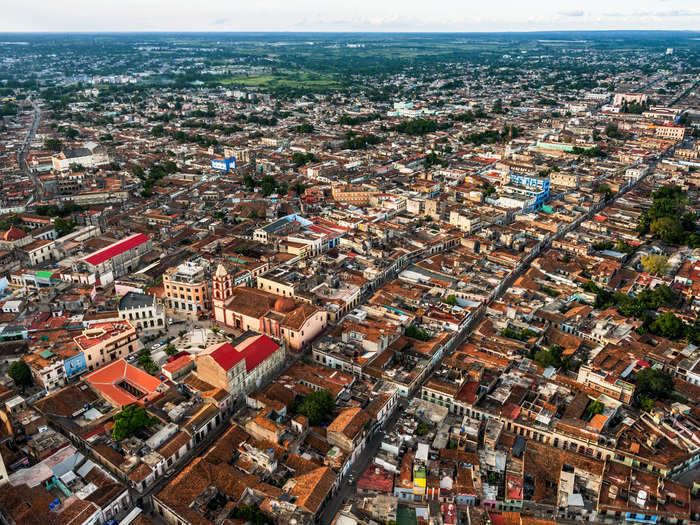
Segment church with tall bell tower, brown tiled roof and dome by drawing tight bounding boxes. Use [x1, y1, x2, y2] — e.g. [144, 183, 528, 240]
[212, 265, 328, 350]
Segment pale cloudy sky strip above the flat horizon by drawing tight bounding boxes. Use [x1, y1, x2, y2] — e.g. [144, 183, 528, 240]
[0, 0, 700, 32]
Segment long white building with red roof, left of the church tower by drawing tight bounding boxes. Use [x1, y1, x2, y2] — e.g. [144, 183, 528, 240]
[83, 233, 153, 278]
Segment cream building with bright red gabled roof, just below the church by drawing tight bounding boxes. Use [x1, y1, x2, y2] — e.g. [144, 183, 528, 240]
[197, 332, 285, 397]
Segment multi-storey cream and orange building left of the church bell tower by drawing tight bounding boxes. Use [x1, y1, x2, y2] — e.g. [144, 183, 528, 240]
[163, 263, 211, 319]
